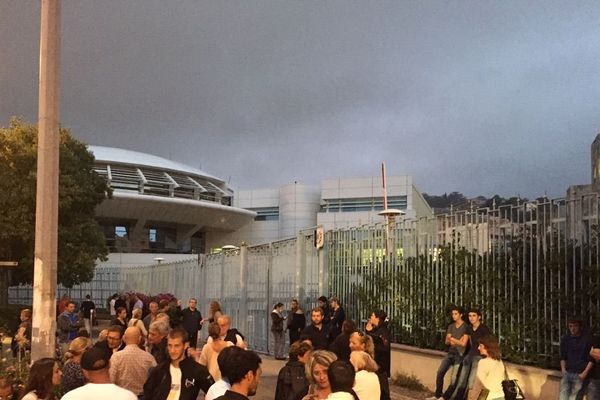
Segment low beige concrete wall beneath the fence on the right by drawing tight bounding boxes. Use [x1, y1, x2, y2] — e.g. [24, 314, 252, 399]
[392, 344, 560, 400]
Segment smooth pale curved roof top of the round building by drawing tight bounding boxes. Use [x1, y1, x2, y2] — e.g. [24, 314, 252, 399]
[88, 145, 224, 182]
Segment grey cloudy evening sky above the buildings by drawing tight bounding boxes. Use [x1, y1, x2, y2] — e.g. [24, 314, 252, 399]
[0, 0, 600, 198]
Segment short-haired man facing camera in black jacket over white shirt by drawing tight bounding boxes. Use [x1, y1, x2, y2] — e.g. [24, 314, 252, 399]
[144, 328, 215, 400]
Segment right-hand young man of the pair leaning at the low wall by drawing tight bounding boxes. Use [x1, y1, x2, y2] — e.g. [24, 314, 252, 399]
[452, 308, 492, 400]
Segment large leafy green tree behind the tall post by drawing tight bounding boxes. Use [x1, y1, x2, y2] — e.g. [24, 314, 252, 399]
[0, 118, 111, 287]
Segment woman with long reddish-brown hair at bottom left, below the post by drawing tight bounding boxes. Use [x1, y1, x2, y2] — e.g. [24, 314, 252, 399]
[20, 358, 62, 400]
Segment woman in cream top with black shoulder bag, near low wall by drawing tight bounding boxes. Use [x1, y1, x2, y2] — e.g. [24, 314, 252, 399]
[468, 335, 505, 400]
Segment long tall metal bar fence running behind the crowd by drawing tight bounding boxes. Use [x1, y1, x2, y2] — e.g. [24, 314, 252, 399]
[9, 195, 600, 366]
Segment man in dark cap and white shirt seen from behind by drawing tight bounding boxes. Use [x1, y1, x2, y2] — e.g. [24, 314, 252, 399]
[62, 347, 138, 400]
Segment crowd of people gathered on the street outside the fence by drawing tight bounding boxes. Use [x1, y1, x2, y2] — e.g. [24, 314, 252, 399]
[8, 296, 600, 400]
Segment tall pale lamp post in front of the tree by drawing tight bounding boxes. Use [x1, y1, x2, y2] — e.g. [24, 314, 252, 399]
[31, 0, 60, 360]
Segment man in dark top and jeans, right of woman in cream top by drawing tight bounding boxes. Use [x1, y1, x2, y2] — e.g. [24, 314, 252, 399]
[560, 318, 594, 400]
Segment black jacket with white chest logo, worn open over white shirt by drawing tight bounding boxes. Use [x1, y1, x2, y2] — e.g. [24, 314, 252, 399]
[144, 358, 215, 400]
